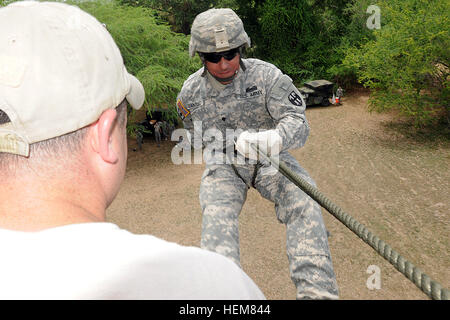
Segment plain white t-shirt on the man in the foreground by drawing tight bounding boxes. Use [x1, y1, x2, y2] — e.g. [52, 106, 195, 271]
[0, 222, 265, 300]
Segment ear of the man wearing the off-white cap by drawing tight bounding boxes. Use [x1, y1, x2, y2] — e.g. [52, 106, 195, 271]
[90, 109, 119, 164]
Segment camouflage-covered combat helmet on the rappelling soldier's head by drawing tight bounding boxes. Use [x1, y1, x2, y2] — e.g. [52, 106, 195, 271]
[189, 8, 250, 57]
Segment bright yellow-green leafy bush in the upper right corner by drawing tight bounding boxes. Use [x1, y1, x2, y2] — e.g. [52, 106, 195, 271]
[342, 0, 450, 127]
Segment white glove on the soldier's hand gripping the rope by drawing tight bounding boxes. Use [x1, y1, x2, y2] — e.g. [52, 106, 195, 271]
[236, 130, 282, 160]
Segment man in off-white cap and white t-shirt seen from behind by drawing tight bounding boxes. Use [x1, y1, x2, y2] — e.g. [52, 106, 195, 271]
[0, 1, 264, 299]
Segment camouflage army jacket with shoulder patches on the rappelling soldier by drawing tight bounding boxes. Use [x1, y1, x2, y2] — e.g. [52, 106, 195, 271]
[177, 59, 309, 154]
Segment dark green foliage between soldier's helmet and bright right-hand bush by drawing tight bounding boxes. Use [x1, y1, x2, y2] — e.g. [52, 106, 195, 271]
[236, 0, 352, 83]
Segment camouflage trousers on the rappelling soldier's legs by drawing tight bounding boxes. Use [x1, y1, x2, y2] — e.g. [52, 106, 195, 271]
[200, 152, 338, 299]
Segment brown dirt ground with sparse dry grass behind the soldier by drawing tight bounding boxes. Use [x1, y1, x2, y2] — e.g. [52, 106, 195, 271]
[107, 91, 450, 300]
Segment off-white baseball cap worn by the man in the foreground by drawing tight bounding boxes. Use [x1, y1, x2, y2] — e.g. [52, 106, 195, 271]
[0, 1, 145, 156]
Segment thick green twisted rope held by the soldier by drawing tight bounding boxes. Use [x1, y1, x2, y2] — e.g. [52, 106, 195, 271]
[250, 144, 450, 300]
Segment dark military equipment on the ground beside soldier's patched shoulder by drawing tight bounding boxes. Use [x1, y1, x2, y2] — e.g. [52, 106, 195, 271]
[299, 80, 334, 107]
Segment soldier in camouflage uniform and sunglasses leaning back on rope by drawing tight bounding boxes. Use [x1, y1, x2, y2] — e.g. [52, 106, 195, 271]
[177, 9, 338, 299]
